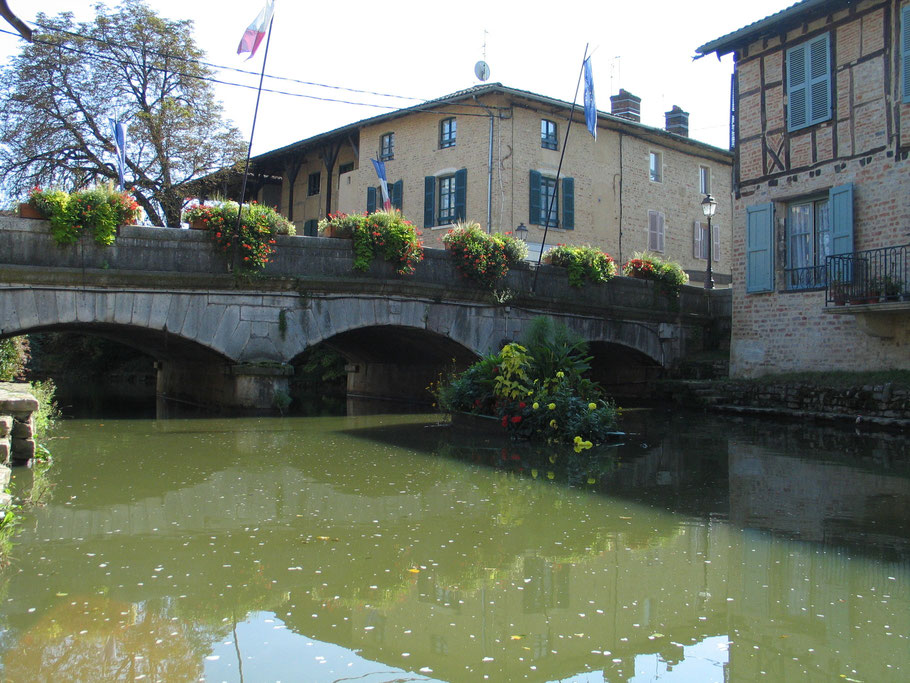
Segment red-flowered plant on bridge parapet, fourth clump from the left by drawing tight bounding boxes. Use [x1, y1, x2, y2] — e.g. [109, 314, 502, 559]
[442, 222, 527, 290]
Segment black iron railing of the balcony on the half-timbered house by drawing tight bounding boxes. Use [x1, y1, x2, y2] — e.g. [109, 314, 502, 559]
[823, 244, 910, 306]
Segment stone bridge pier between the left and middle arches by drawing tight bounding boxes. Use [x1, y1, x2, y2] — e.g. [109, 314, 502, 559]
[156, 360, 294, 414]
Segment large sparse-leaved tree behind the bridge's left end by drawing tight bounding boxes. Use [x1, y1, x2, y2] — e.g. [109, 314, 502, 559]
[0, 0, 245, 226]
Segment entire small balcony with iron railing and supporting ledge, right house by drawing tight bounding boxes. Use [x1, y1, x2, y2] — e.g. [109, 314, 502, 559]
[817, 244, 910, 339]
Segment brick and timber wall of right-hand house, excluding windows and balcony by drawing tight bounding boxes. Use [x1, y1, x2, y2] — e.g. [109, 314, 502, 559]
[730, 0, 910, 377]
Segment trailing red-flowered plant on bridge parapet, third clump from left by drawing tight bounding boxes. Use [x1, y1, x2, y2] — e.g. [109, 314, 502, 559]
[318, 209, 423, 275]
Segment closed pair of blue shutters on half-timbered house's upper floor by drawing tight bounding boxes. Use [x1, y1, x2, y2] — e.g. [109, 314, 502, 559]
[787, 33, 831, 130]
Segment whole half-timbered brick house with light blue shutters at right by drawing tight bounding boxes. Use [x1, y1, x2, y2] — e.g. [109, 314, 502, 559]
[697, 0, 910, 377]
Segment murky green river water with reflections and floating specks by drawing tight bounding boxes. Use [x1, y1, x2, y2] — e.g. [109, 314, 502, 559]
[0, 408, 910, 682]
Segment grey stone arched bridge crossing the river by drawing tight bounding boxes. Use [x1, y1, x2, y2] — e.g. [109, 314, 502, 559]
[0, 218, 729, 408]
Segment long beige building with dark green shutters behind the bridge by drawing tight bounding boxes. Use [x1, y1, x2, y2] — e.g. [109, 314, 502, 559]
[244, 84, 732, 286]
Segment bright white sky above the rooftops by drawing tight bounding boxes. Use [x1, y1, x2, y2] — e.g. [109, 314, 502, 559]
[0, 0, 793, 154]
